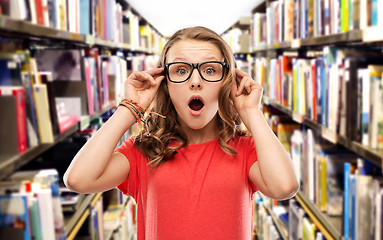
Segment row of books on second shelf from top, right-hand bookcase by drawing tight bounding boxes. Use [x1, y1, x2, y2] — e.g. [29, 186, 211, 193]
[253, 47, 383, 149]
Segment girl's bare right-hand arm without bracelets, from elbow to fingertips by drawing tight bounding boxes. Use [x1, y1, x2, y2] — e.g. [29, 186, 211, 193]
[232, 69, 299, 200]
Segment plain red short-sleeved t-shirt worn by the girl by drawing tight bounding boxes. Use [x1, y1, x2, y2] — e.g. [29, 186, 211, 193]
[116, 137, 257, 240]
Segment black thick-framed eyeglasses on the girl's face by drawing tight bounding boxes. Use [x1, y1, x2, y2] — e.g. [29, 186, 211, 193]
[165, 61, 227, 83]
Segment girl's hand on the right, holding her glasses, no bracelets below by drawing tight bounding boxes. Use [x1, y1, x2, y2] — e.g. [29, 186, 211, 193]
[231, 68, 263, 115]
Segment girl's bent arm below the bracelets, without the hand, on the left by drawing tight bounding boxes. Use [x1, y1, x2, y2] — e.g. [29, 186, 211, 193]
[64, 107, 136, 193]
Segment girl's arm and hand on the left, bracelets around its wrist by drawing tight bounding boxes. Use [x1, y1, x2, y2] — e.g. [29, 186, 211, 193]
[64, 68, 164, 193]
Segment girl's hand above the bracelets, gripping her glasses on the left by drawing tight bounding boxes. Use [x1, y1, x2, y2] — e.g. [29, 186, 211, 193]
[124, 68, 165, 108]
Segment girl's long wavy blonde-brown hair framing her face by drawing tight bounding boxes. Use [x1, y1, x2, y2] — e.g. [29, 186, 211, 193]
[134, 27, 246, 169]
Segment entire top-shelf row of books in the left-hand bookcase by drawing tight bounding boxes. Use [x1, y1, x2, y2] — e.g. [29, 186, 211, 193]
[0, 0, 165, 52]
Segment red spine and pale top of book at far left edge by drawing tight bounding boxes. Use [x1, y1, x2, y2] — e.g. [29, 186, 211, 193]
[0, 86, 28, 153]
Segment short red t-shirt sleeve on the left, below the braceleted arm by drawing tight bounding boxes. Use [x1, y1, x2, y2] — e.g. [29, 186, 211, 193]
[114, 139, 139, 199]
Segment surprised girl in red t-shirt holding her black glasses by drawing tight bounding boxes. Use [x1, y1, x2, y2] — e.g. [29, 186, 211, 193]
[64, 27, 299, 239]
